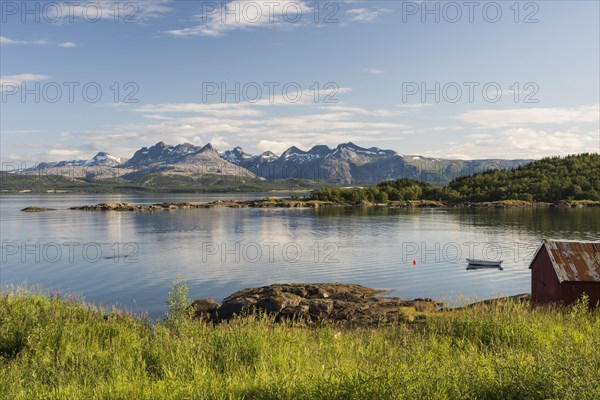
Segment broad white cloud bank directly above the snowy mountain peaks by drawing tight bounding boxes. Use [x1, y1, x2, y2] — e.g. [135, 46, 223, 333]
[21, 97, 410, 161]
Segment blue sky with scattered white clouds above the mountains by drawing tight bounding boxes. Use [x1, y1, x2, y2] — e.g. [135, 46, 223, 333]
[0, 0, 600, 166]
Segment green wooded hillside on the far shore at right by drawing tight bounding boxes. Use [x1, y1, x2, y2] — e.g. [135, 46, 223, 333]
[311, 154, 600, 204]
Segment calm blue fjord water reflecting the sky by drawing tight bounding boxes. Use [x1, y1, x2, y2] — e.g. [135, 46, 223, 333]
[0, 194, 600, 317]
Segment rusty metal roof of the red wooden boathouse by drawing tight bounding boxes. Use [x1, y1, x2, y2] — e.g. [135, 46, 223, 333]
[532, 240, 600, 283]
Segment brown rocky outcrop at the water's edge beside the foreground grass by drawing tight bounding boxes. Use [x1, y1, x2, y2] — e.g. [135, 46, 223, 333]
[192, 283, 441, 326]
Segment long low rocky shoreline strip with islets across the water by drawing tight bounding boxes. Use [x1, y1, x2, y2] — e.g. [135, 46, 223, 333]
[21, 198, 600, 212]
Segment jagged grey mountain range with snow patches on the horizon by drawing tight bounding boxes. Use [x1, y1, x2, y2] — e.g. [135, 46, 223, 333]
[19, 142, 532, 185]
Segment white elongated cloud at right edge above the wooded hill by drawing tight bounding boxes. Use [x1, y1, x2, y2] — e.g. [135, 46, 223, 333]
[456, 104, 600, 128]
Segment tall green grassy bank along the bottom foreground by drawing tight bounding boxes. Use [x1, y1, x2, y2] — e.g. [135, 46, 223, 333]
[0, 294, 600, 400]
